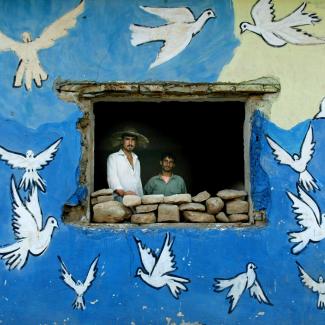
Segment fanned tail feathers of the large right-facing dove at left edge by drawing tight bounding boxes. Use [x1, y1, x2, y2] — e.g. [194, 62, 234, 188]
[0, 242, 28, 271]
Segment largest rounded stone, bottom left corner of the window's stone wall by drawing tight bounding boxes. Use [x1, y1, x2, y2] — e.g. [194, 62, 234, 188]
[93, 201, 132, 223]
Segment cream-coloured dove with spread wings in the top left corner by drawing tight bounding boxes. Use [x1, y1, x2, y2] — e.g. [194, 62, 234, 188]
[0, 0, 84, 90]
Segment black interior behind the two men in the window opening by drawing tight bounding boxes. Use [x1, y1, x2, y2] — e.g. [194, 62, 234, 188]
[94, 102, 245, 195]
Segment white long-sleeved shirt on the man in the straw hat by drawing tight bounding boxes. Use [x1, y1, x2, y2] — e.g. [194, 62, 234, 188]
[107, 149, 143, 196]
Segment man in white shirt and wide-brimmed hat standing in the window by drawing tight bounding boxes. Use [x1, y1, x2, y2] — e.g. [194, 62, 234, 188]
[107, 128, 149, 201]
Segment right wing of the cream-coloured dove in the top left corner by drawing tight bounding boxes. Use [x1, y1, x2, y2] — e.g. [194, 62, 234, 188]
[33, 0, 85, 50]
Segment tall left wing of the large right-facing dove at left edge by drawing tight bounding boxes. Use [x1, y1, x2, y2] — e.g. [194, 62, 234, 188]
[11, 177, 40, 239]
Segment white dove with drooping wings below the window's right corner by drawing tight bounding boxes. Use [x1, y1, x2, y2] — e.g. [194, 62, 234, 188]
[213, 263, 272, 314]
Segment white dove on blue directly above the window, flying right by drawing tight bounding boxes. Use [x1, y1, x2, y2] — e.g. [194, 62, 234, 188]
[130, 6, 215, 69]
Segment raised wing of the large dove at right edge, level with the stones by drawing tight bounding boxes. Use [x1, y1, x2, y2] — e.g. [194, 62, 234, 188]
[287, 192, 321, 227]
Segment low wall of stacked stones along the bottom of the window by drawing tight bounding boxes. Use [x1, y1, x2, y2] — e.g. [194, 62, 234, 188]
[91, 189, 249, 224]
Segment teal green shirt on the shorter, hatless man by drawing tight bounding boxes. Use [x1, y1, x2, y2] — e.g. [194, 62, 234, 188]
[144, 175, 187, 196]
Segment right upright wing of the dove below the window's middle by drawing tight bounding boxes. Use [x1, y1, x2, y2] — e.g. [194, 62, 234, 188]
[152, 233, 176, 277]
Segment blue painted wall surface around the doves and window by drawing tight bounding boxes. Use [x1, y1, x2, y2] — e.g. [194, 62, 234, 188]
[0, 0, 325, 325]
